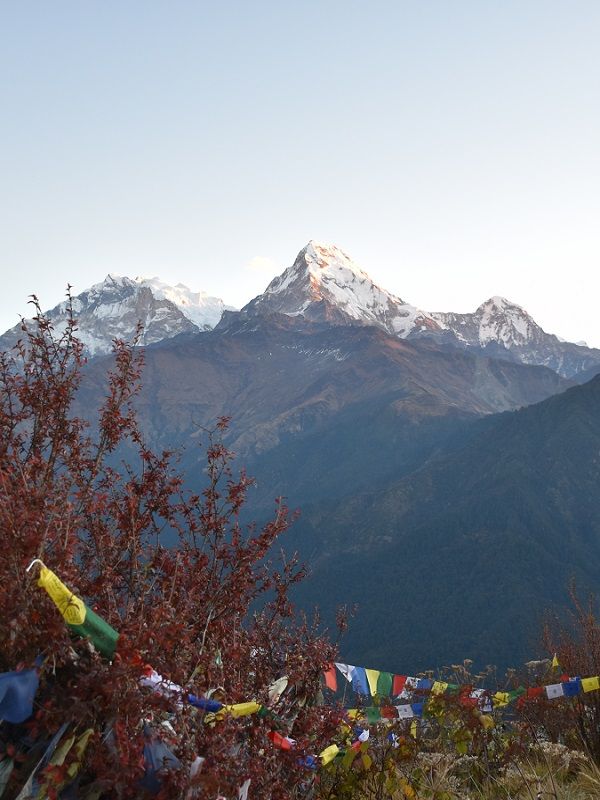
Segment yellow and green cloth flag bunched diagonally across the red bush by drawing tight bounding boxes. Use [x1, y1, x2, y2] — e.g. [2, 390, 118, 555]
[38, 564, 119, 658]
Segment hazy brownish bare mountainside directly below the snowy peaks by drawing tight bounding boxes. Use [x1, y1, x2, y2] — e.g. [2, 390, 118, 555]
[77, 315, 569, 484]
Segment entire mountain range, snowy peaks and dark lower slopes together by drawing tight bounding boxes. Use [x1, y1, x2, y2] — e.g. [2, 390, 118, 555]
[0, 242, 600, 672]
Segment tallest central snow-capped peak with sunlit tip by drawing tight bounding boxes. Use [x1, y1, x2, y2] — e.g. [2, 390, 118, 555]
[244, 240, 439, 337]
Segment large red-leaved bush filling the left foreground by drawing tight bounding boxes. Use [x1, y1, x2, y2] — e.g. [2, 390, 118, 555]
[0, 299, 336, 798]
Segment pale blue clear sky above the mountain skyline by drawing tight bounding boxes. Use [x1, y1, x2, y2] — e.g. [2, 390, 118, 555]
[0, 0, 600, 347]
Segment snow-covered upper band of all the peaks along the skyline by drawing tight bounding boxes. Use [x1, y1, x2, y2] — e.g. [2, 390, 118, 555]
[0, 241, 600, 380]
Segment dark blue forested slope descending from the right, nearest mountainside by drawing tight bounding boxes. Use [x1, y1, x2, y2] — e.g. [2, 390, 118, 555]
[298, 377, 600, 672]
